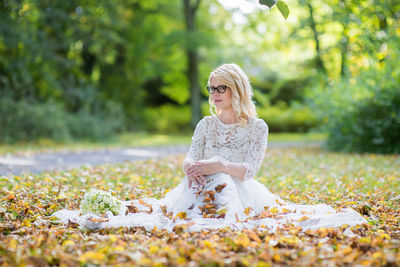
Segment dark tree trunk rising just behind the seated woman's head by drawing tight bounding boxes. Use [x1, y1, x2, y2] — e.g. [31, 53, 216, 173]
[183, 0, 201, 128]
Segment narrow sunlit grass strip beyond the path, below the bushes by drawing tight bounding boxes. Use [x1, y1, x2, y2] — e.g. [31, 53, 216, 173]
[0, 133, 326, 155]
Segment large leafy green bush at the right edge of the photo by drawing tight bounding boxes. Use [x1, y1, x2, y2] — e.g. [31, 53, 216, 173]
[310, 40, 400, 153]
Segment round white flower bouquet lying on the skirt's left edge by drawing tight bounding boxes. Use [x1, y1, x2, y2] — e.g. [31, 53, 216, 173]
[79, 190, 122, 215]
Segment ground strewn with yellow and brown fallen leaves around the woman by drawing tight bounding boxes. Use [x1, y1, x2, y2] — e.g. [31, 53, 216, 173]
[0, 148, 400, 266]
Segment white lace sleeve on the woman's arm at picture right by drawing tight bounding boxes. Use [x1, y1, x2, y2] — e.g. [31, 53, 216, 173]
[243, 119, 268, 180]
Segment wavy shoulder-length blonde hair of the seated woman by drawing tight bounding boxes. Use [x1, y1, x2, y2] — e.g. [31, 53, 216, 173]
[208, 64, 257, 126]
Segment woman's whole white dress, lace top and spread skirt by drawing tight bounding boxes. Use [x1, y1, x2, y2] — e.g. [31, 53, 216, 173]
[53, 116, 367, 231]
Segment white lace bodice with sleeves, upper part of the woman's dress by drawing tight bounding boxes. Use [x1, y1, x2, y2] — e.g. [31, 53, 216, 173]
[184, 116, 268, 180]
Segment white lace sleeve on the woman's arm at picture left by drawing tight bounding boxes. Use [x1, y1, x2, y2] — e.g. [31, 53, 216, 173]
[183, 118, 207, 174]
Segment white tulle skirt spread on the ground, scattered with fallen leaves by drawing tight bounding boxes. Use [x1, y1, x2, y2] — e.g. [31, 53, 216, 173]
[53, 172, 367, 232]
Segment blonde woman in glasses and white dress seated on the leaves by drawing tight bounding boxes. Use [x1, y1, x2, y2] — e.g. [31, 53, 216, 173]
[54, 64, 367, 231]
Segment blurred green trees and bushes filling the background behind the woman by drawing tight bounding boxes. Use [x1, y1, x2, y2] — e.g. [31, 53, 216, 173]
[0, 0, 400, 153]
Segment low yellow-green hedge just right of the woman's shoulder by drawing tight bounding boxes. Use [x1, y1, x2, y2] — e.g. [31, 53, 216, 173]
[257, 102, 320, 132]
